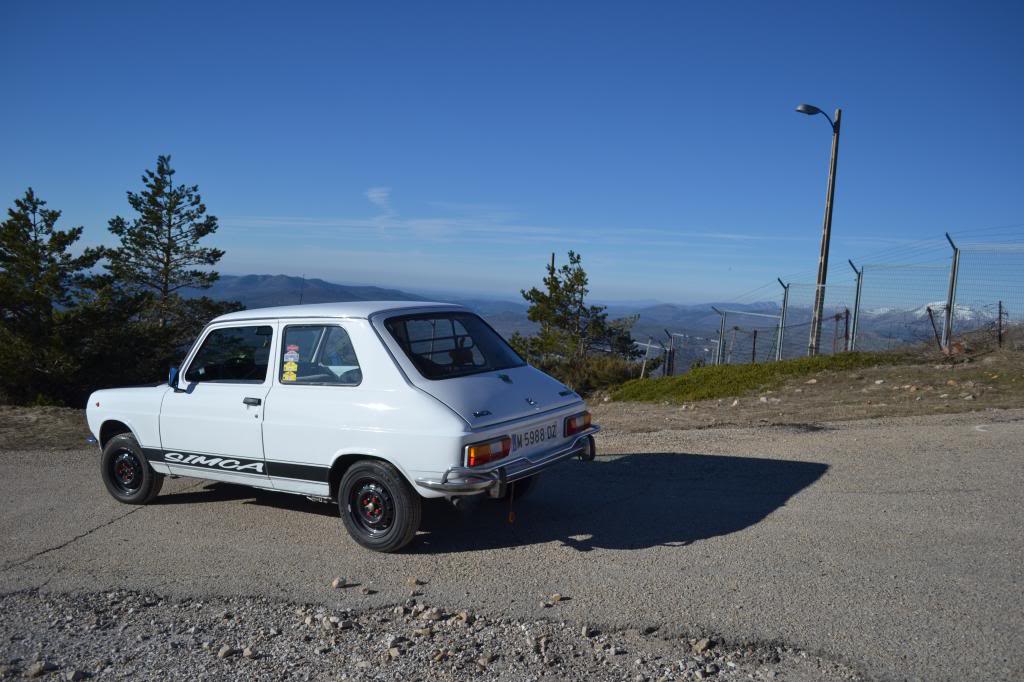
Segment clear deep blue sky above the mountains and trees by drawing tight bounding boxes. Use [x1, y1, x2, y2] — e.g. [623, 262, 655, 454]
[0, 2, 1024, 302]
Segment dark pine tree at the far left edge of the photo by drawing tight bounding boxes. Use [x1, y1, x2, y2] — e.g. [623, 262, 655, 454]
[0, 187, 102, 401]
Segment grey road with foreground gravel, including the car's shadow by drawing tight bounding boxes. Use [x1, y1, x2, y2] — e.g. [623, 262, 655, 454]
[0, 410, 1024, 680]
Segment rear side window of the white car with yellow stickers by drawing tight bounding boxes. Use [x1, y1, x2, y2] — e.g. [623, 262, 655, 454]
[279, 325, 362, 386]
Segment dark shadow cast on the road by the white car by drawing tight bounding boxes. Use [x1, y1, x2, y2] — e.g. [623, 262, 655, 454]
[151, 453, 828, 553]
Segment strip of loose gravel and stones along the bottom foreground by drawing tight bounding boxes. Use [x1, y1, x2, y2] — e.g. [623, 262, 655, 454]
[0, 586, 861, 682]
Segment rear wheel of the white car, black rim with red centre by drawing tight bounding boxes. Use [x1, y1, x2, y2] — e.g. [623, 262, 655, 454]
[338, 460, 423, 552]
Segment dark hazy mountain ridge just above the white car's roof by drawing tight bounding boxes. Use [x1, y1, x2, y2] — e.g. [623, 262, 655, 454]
[186, 274, 427, 308]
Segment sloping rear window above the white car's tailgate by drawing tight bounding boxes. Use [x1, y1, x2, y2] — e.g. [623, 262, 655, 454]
[384, 312, 525, 379]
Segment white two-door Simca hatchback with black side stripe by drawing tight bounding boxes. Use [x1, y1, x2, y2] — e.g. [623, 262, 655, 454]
[86, 301, 599, 552]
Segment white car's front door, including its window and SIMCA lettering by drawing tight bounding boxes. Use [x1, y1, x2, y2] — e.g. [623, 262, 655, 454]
[160, 322, 278, 487]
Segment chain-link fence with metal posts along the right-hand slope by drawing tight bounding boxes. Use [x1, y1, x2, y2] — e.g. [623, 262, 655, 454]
[658, 236, 1024, 374]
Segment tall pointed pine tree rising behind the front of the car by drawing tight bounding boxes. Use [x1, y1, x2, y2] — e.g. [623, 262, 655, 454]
[109, 156, 224, 327]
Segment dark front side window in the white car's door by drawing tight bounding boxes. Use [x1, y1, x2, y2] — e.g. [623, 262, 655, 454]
[185, 325, 273, 384]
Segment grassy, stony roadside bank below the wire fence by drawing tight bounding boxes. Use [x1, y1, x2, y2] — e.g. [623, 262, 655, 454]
[591, 330, 1024, 432]
